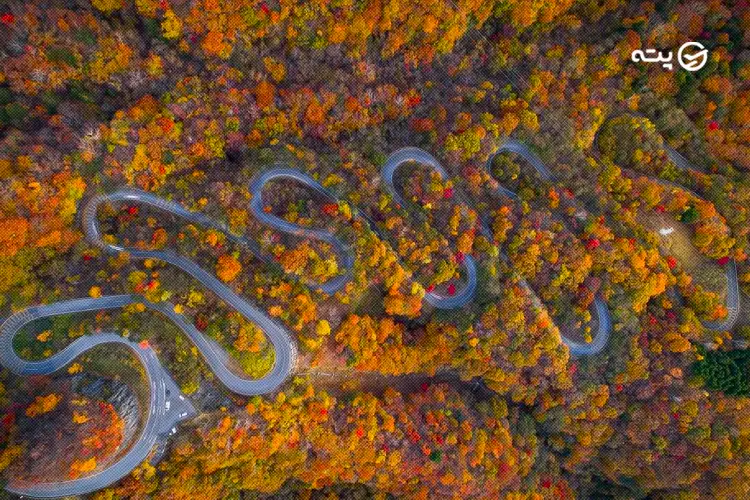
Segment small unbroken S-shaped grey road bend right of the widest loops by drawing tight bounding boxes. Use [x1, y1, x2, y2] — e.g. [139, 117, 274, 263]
[250, 166, 354, 295]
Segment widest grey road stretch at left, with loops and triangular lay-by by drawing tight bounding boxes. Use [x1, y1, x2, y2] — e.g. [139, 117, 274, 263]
[0, 189, 297, 498]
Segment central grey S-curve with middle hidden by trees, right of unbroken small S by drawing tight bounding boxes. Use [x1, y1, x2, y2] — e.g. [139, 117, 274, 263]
[380, 147, 477, 309]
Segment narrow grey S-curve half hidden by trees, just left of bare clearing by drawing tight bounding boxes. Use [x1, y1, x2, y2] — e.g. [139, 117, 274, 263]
[485, 139, 612, 356]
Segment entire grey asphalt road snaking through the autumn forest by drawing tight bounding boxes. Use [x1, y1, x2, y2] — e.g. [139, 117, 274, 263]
[0, 141, 612, 498]
